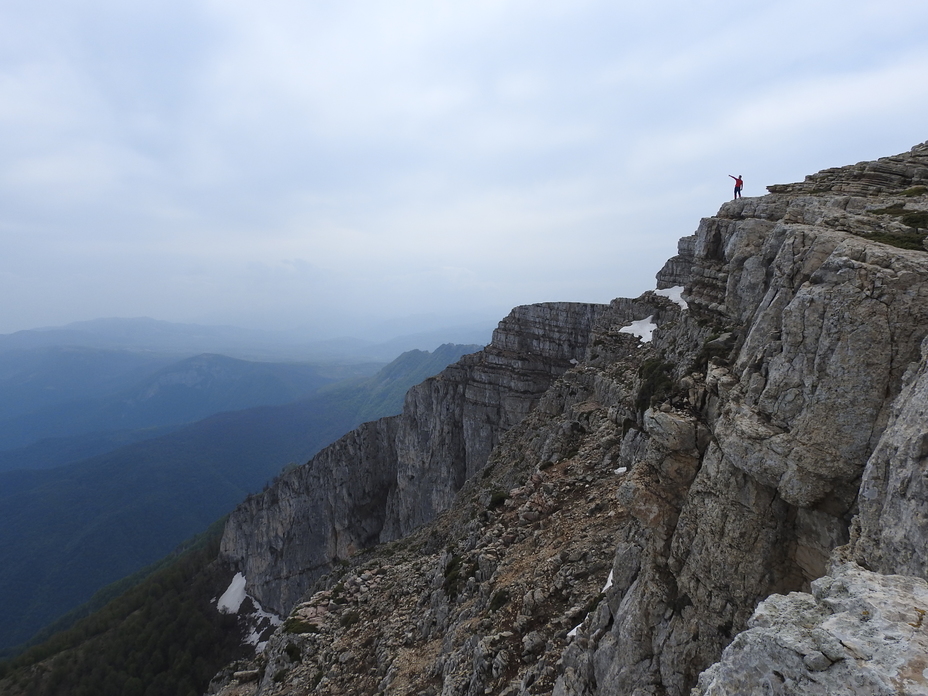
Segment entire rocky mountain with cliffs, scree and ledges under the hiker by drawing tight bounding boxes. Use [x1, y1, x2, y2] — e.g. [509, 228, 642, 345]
[209, 143, 928, 696]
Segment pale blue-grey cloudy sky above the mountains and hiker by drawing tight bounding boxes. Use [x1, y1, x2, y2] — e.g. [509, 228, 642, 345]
[0, 0, 928, 338]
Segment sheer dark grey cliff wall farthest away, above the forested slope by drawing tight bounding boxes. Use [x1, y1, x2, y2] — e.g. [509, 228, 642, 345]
[221, 303, 624, 613]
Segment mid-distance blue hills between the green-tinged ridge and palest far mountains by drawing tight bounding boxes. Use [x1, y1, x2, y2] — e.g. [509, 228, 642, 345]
[0, 347, 379, 460]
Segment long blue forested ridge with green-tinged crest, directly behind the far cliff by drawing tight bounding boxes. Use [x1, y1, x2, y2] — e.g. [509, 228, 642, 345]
[0, 345, 479, 649]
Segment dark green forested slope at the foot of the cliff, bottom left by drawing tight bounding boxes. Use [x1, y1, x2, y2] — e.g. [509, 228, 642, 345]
[0, 525, 244, 696]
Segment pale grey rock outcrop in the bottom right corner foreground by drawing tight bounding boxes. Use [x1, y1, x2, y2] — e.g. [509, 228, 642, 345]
[692, 564, 928, 696]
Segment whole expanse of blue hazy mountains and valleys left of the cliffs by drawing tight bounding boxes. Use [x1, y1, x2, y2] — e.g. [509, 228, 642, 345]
[0, 320, 482, 651]
